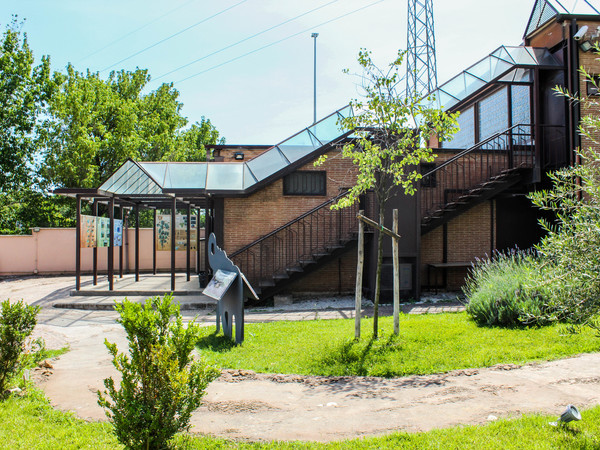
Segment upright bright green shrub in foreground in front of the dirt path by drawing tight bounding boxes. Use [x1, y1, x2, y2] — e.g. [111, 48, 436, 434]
[98, 295, 219, 449]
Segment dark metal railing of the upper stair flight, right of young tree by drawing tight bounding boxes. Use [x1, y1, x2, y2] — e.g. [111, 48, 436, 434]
[421, 124, 535, 218]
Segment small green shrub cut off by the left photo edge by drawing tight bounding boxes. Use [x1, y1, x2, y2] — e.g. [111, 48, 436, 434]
[0, 300, 40, 398]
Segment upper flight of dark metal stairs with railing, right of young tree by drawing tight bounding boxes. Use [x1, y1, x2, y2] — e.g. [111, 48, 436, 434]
[421, 124, 535, 234]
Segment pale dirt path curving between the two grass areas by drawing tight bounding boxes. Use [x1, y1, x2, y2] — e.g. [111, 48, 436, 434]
[31, 323, 600, 441]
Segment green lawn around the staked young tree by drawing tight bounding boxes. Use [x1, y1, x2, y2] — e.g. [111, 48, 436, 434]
[198, 313, 600, 377]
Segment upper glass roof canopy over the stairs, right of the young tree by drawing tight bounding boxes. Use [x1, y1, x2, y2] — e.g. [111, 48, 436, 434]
[429, 45, 562, 110]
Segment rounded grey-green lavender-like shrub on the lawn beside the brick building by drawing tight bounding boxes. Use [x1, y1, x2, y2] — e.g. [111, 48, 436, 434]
[463, 251, 549, 326]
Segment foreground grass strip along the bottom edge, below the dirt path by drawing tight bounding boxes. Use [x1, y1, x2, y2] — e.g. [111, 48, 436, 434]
[0, 390, 600, 450]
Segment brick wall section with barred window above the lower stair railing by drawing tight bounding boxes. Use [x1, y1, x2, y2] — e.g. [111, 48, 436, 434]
[223, 151, 356, 253]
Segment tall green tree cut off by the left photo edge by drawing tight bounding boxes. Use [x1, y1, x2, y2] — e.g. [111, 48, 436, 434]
[0, 17, 65, 234]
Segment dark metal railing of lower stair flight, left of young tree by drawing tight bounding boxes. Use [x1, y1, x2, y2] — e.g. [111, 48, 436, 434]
[230, 192, 364, 287]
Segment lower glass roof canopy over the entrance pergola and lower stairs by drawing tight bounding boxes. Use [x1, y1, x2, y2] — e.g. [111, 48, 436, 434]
[99, 106, 352, 196]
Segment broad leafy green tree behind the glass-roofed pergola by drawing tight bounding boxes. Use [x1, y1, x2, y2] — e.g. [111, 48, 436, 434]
[41, 66, 219, 188]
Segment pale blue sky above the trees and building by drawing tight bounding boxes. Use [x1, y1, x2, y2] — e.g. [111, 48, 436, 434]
[0, 0, 534, 144]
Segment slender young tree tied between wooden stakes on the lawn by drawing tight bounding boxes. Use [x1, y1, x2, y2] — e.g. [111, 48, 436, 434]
[318, 49, 457, 338]
